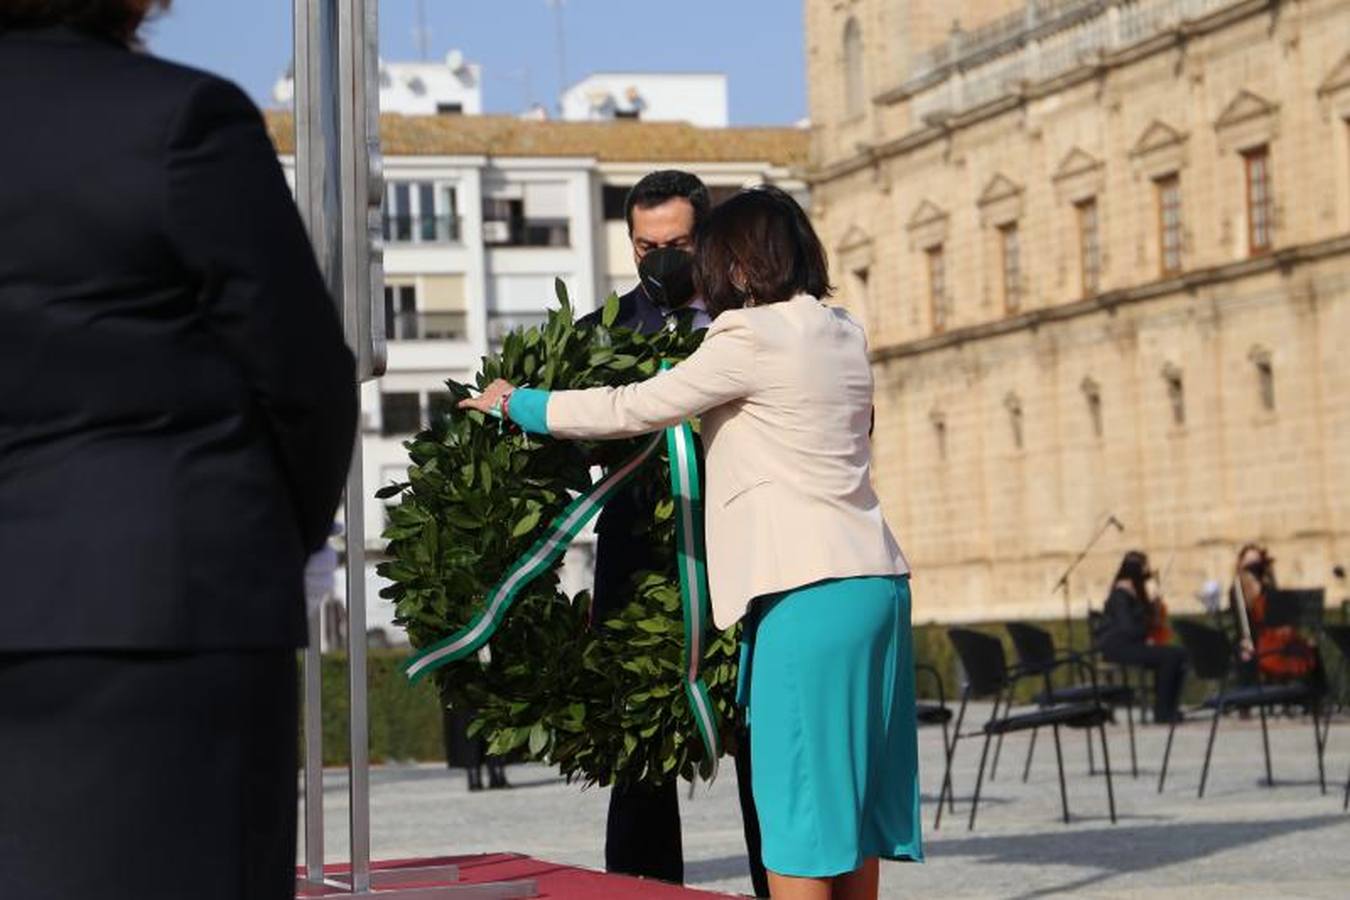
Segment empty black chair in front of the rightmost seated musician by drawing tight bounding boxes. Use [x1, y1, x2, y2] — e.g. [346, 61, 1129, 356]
[1158, 621, 1327, 797]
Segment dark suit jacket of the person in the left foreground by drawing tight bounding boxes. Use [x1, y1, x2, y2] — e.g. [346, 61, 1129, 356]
[0, 28, 356, 652]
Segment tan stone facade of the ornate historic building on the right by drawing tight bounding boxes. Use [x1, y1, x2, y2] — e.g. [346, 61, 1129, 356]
[805, 0, 1350, 621]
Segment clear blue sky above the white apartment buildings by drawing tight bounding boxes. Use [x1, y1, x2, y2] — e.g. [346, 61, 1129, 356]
[147, 0, 806, 125]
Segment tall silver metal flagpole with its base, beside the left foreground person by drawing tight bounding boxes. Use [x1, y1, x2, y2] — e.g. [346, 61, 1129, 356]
[294, 0, 537, 900]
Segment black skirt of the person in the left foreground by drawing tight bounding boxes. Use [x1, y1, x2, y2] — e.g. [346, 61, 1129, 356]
[0, 649, 298, 900]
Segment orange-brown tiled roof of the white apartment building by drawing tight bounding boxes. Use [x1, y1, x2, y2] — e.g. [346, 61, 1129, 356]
[266, 112, 807, 167]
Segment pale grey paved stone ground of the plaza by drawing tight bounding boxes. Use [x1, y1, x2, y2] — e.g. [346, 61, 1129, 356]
[306, 718, 1350, 897]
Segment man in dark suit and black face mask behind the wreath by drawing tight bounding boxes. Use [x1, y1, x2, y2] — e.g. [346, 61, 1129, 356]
[582, 170, 768, 897]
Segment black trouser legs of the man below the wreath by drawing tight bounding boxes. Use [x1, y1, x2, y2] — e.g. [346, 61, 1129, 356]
[605, 735, 768, 897]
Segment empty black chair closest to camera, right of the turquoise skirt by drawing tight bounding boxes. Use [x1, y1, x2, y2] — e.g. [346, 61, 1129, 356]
[933, 629, 1115, 830]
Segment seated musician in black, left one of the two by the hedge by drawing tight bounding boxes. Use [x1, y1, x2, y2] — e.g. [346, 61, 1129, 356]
[1092, 551, 1185, 723]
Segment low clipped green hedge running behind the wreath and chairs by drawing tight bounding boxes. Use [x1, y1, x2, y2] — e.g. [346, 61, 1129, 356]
[310, 617, 1342, 765]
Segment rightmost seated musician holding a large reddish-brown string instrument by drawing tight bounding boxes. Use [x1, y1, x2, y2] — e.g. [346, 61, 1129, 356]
[1229, 544, 1322, 683]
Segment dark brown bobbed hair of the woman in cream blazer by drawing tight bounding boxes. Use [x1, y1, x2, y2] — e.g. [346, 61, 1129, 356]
[694, 185, 834, 317]
